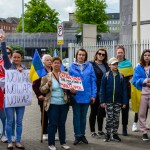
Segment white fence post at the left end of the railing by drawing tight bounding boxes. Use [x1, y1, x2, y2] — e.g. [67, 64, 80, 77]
[68, 43, 74, 66]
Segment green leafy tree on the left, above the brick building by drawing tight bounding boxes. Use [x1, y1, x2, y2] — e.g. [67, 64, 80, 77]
[17, 0, 59, 33]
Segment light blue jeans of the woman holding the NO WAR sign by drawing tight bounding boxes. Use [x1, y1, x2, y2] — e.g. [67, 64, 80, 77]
[5, 106, 25, 143]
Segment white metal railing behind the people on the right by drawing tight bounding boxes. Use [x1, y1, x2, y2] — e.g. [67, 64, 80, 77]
[68, 40, 150, 66]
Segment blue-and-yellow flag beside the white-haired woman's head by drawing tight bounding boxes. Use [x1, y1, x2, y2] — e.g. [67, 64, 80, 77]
[29, 50, 47, 82]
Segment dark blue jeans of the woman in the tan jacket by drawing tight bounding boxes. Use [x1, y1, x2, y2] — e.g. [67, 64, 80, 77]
[48, 104, 69, 145]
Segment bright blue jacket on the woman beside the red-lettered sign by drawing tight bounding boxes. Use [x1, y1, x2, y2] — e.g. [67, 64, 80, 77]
[68, 62, 97, 104]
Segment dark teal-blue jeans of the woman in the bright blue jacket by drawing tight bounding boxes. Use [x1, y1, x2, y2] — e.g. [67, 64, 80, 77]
[72, 103, 89, 137]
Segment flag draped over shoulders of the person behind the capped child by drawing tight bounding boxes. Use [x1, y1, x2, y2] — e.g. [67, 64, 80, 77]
[118, 59, 133, 77]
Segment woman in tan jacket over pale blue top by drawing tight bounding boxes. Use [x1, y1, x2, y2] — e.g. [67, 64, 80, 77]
[40, 57, 75, 150]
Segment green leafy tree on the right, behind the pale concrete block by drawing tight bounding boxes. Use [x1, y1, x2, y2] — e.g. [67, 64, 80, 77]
[75, 0, 109, 32]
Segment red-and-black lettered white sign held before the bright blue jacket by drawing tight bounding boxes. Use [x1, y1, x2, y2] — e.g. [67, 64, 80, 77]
[59, 73, 84, 91]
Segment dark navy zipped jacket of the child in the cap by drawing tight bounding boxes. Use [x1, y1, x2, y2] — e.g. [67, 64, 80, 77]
[100, 71, 128, 104]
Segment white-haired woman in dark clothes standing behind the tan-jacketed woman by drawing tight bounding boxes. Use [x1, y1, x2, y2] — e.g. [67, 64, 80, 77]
[32, 54, 52, 140]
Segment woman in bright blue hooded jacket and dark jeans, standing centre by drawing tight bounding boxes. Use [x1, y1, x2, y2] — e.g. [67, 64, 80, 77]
[69, 49, 97, 145]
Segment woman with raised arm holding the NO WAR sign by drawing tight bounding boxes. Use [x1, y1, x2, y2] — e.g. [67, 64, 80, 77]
[0, 33, 27, 150]
